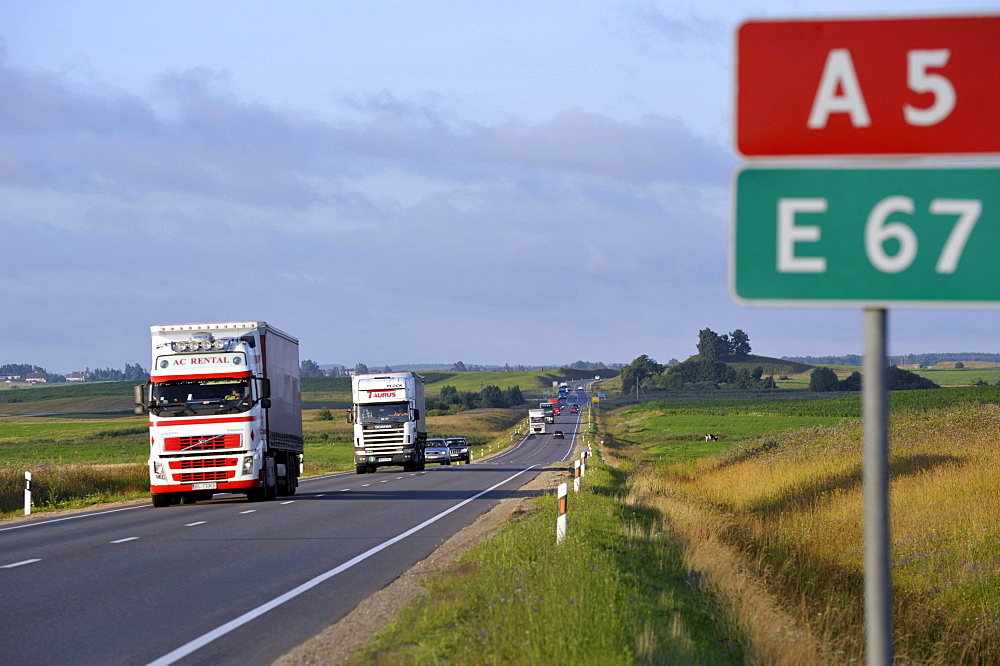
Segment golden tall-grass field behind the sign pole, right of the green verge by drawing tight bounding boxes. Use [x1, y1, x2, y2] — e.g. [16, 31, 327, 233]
[602, 387, 1000, 664]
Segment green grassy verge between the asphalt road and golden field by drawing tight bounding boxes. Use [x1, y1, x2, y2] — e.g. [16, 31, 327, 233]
[350, 458, 744, 665]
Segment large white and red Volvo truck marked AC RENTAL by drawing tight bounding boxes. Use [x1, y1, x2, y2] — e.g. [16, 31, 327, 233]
[134, 321, 302, 507]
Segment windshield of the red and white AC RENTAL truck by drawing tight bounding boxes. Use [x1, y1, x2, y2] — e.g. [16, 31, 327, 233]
[150, 378, 252, 416]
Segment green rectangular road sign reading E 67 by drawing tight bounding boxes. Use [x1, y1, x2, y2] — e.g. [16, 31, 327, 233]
[730, 167, 1000, 307]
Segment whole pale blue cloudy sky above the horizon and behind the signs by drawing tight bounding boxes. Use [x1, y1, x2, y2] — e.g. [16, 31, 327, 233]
[0, 0, 1000, 373]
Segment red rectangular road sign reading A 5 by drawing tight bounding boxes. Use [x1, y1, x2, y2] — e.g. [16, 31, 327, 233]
[736, 16, 1000, 157]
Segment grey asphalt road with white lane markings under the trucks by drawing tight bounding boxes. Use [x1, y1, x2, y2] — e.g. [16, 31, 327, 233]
[0, 384, 589, 665]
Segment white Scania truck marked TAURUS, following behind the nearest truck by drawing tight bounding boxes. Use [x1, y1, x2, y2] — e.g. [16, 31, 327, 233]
[348, 372, 427, 474]
